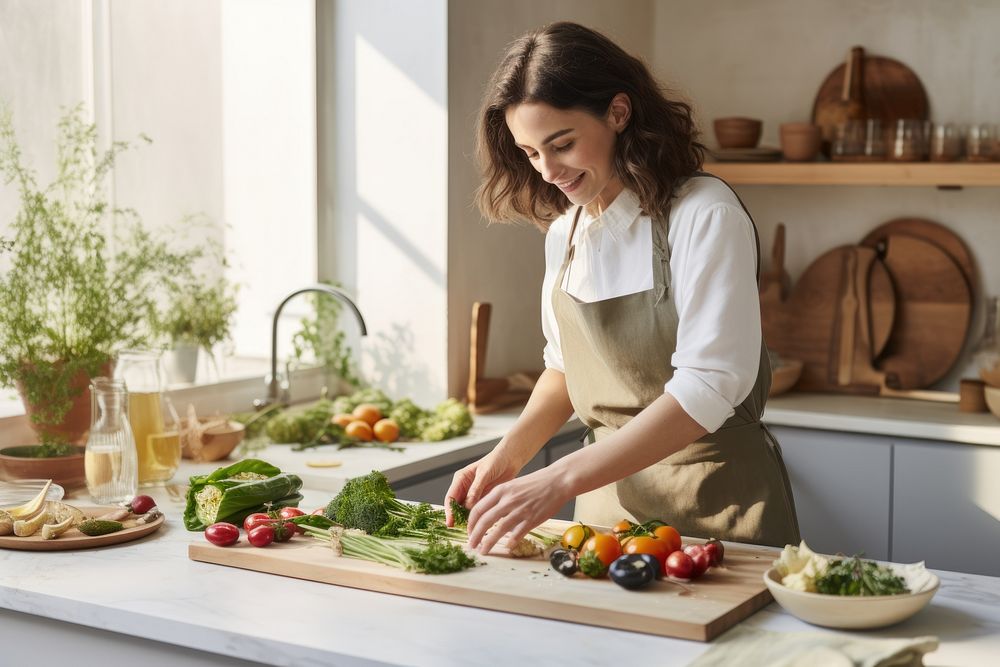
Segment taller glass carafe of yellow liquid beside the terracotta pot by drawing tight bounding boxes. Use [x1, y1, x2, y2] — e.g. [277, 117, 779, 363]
[115, 350, 181, 486]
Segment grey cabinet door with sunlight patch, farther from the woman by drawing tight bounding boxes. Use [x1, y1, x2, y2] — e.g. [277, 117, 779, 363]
[892, 440, 1000, 577]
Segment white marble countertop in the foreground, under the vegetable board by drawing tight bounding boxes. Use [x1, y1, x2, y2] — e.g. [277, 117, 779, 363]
[0, 490, 1000, 667]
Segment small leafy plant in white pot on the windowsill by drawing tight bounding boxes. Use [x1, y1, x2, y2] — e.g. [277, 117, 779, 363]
[156, 278, 236, 382]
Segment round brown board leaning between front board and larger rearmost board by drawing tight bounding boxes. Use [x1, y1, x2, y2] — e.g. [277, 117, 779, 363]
[876, 234, 972, 389]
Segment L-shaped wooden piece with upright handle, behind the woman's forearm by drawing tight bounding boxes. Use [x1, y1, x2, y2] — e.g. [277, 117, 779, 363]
[466, 301, 540, 414]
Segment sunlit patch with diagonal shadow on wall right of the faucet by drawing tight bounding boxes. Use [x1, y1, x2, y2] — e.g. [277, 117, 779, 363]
[354, 35, 448, 400]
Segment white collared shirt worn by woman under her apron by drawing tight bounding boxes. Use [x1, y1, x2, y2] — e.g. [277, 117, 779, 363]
[542, 177, 761, 432]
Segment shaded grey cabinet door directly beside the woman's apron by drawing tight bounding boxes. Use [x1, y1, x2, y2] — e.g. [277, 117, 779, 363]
[771, 426, 892, 560]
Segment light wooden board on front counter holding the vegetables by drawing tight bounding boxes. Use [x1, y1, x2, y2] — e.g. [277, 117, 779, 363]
[188, 522, 778, 641]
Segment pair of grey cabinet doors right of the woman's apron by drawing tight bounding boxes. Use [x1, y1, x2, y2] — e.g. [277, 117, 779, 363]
[770, 426, 1000, 576]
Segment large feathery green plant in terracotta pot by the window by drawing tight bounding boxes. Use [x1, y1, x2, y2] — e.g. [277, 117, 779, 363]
[0, 105, 202, 454]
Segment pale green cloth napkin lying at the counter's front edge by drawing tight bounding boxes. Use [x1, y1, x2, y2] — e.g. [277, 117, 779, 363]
[691, 626, 938, 667]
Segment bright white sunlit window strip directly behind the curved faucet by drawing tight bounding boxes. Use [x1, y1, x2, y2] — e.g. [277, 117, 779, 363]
[222, 0, 317, 356]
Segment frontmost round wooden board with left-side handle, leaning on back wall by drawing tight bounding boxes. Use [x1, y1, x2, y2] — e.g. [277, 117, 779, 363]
[761, 245, 895, 394]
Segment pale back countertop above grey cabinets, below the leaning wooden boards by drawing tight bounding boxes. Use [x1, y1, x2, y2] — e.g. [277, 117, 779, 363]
[764, 392, 1000, 446]
